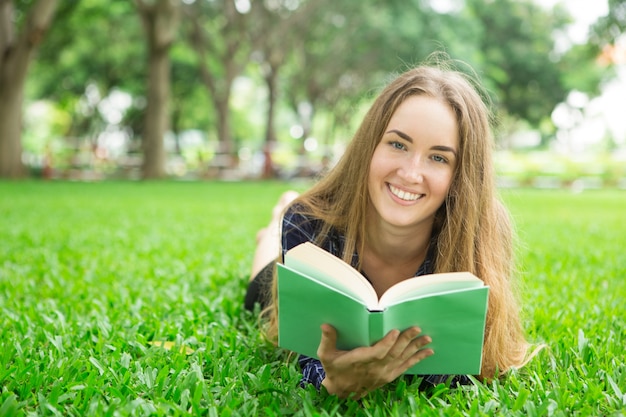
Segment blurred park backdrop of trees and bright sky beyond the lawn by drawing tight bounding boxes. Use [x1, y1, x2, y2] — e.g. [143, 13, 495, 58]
[0, 0, 626, 188]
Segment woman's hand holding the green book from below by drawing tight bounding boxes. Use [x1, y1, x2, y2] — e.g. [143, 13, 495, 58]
[317, 324, 434, 398]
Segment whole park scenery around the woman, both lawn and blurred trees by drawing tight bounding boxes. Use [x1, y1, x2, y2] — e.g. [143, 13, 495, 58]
[0, 0, 626, 417]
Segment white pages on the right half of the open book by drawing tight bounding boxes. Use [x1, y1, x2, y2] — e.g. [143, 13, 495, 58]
[379, 272, 485, 308]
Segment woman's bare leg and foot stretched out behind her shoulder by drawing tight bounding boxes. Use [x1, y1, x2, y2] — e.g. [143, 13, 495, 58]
[250, 191, 299, 280]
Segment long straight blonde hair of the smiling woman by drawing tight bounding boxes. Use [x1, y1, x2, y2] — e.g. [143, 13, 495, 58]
[268, 66, 529, 379]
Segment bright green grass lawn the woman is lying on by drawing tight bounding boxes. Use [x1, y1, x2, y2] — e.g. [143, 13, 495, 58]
[0, 182, 626, 416]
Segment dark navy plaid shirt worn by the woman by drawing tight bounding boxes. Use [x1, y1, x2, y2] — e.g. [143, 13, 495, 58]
[281, 206, 471, 390]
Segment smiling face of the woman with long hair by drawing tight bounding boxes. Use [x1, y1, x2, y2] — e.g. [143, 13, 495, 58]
[368, 96, 459, 231]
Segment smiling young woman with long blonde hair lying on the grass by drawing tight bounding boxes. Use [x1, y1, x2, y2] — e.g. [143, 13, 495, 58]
[246, 62, 529, 398]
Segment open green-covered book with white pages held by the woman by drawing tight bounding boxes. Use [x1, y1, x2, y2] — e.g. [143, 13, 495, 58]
[277, 242, 489, 374]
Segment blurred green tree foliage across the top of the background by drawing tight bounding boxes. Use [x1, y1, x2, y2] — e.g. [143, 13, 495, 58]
[0, 0, 625, 176]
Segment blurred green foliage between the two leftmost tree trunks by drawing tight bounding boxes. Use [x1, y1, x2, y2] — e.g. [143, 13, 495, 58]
[28, 0, 147, 166]
